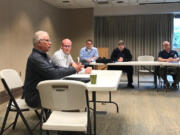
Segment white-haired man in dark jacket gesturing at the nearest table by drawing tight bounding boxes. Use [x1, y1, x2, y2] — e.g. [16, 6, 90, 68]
[24, 31, 81, 107]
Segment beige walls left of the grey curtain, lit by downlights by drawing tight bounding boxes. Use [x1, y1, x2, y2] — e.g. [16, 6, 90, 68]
[0, 0, 93, 91]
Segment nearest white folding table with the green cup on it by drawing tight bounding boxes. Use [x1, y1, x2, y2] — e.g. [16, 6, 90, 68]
[68, 70, 122, 135]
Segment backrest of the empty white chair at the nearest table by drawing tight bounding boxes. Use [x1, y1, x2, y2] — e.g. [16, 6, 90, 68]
[37, 80, 87, 110]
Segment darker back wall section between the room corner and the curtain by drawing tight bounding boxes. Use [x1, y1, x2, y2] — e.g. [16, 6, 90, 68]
[60, 9, 94, 61]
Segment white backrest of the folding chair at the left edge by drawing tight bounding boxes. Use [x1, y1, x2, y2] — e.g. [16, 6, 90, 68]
[0, 69, 23, 90]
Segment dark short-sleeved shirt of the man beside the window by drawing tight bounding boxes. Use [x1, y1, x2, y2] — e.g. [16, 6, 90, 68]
[158, 50, 179, 59]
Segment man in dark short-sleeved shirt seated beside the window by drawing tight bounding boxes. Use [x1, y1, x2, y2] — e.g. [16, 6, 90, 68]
[157, 41, 180, 89]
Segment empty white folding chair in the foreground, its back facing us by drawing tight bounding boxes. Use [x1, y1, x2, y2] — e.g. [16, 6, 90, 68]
[37, 80, 91, 134]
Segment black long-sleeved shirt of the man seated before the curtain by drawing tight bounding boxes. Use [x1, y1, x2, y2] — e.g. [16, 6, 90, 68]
[111, 48, 132, 62]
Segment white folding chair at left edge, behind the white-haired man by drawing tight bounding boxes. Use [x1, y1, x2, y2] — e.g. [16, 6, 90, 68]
[0, 69, 40, 135]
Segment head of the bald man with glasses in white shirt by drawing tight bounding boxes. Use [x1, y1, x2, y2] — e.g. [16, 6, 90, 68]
[61, 38, 72, 55]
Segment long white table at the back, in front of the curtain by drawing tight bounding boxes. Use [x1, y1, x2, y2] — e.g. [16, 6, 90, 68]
[90, 61, 180, 88]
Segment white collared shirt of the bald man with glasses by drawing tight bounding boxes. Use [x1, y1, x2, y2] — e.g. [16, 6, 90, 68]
[52, 49, 74, 67]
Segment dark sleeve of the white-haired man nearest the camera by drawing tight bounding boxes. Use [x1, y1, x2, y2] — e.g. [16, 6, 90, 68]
[28, 57, 76, 80]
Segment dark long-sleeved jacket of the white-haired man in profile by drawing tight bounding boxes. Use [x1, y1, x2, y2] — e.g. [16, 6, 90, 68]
[24, 48, 76, 107]
